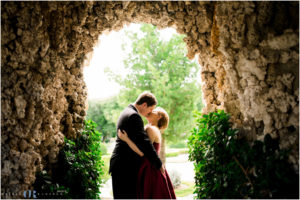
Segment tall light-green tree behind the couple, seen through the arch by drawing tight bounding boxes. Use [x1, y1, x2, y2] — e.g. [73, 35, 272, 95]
[106, 24, 201, 161]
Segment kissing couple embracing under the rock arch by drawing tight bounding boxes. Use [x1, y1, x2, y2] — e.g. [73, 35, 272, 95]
[109, 92, 176, 199]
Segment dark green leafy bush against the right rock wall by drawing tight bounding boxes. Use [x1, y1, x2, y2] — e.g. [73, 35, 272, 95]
[188, 111, 299, 199]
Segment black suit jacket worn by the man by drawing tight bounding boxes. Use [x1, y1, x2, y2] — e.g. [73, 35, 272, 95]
[109, 104, 162, 173]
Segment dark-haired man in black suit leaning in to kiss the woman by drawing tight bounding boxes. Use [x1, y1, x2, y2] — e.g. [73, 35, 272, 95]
[109, 92, 165, 199]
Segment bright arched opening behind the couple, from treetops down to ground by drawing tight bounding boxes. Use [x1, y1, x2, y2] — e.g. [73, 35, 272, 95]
[84, 24, 203, 198]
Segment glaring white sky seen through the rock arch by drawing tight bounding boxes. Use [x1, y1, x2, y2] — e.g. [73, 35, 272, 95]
[84, 24, 195, 99]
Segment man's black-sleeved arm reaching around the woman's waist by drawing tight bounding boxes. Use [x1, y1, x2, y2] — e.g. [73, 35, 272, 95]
[128, 114, 162, 169]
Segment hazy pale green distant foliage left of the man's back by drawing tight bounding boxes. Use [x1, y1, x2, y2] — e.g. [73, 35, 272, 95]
[86, 98, 121, 142]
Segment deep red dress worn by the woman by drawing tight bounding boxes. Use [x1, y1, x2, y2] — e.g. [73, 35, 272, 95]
[137, 142, 176, 199]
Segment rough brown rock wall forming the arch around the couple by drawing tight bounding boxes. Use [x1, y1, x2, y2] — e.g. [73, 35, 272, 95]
[1, 1, 299, 198]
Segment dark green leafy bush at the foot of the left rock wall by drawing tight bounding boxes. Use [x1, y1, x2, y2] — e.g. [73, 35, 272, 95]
[33, 121, 103, 199]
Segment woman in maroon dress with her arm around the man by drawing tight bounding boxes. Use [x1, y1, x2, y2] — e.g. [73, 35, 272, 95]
[118, 107, 176, 199]
